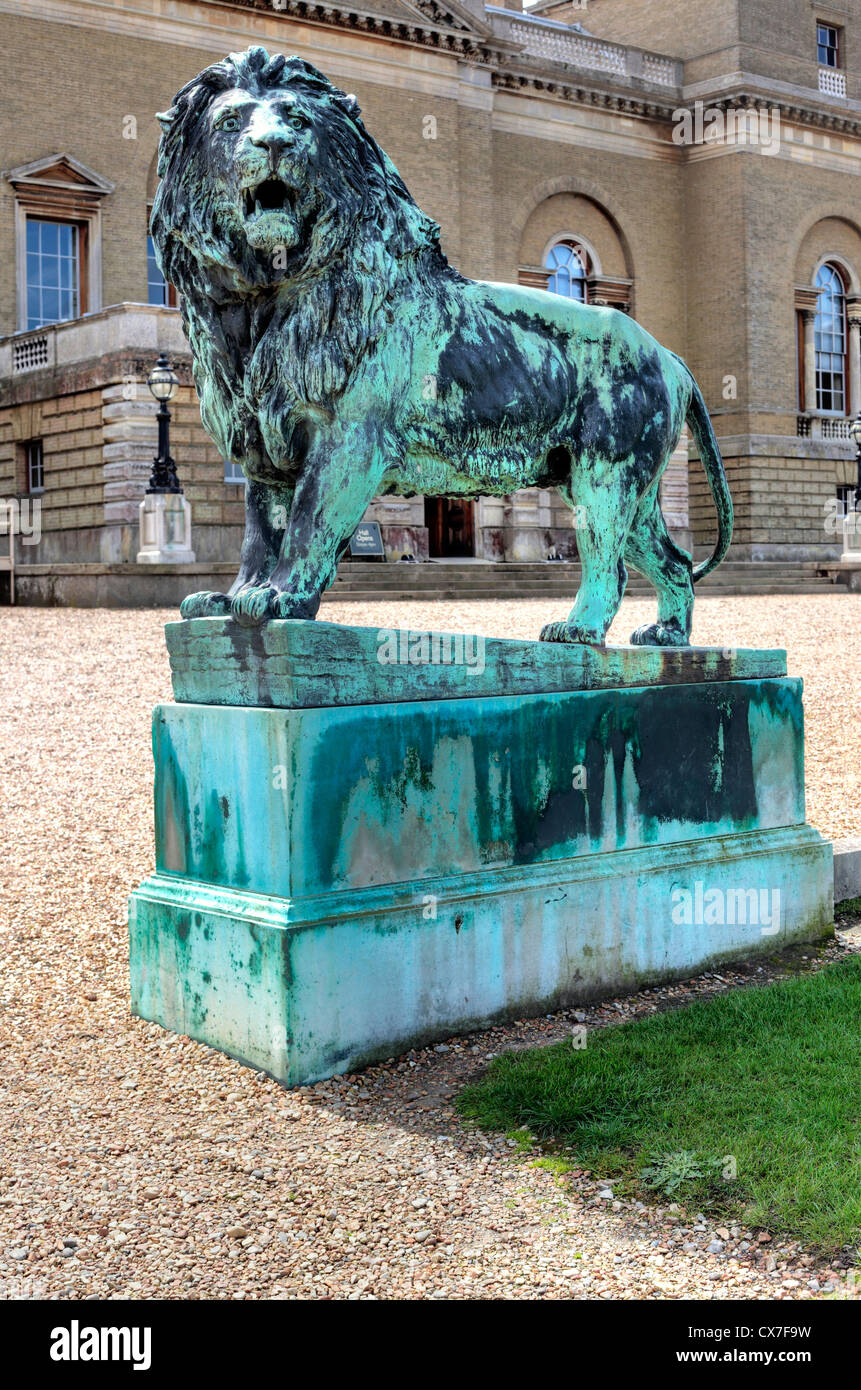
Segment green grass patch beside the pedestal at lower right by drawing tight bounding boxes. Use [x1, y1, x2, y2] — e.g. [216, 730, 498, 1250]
[458, 956, 861, 1250]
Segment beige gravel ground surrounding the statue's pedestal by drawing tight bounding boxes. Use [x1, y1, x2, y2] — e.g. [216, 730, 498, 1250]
[0, 594, 861, 1298]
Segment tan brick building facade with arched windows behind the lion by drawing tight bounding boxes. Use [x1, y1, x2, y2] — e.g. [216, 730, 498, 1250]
[0, 0, 861, 586]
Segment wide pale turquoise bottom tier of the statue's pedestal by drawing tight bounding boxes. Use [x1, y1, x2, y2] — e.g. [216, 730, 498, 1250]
[131, 827, 833, 1086]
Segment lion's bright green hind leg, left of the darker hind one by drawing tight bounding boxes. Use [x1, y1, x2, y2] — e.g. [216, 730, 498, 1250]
[541, 467, 636, 646]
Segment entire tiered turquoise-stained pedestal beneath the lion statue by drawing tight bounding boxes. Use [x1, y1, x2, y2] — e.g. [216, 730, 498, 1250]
[129, 619, 833, 1086]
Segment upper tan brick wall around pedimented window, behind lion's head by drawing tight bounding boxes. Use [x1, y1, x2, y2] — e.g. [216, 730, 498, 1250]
[0, 14, 467, 335]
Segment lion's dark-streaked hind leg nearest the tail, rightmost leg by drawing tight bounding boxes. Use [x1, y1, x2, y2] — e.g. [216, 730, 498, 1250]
[625, 488, 694, 646]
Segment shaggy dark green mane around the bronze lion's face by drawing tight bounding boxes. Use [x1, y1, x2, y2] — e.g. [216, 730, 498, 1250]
[152, 47, 456, 477]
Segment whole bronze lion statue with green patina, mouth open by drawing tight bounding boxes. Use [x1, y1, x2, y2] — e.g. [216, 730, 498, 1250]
[152, 47, 732, 645]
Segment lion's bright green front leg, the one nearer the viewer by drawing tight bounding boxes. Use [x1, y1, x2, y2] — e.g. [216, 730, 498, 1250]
[231, 432, 385, 624]
